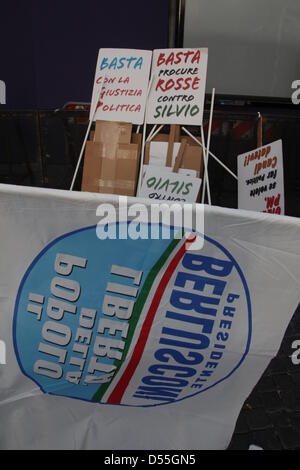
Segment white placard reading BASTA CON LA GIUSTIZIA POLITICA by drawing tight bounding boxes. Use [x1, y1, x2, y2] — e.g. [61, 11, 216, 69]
[90, 49, 152, 124]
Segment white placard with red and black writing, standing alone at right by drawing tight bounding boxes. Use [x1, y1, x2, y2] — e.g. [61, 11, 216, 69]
[238, 140, 284, 215]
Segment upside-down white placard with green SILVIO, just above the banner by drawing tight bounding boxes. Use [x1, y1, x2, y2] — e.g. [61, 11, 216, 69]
[139, 165, 202, 202]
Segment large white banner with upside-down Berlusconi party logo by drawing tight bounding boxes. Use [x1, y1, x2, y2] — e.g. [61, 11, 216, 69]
[0, 185, 300, 450]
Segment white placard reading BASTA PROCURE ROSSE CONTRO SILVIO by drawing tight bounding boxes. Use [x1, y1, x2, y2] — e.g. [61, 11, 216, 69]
[146, 48, 208, 126]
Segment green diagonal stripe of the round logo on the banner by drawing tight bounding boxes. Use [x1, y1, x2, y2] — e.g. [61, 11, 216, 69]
[92, 238, 180, 402]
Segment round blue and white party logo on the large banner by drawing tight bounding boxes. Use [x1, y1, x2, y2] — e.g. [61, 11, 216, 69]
[14, 222, 252, 407]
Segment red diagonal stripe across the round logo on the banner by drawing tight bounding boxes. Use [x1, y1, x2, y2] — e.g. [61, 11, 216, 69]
[107, 235, 196, 404]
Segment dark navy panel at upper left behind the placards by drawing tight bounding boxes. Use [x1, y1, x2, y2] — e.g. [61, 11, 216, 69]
[0, 0, 169, 109]
